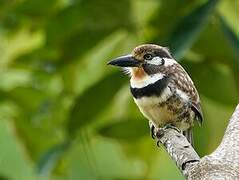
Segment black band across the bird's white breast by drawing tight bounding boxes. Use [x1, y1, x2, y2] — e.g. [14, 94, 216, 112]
[130, 77, 168, 99]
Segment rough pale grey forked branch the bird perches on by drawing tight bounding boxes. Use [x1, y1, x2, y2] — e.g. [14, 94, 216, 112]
[159, 105, 239, 180]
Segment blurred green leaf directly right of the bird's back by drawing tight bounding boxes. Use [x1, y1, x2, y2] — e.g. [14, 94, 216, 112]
[185, 62, 239, 105]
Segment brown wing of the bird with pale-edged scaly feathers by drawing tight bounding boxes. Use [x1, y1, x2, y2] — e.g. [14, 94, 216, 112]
[168, 64, 203, 124]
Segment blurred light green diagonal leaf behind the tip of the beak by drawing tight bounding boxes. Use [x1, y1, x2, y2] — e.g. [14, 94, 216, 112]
[73, 31, 130, 94]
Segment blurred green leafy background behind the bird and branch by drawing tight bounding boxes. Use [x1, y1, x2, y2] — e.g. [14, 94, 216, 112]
[0, 0, 239, 180]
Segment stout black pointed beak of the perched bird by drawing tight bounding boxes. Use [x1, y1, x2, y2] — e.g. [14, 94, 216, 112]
[107, 55, 140, 67]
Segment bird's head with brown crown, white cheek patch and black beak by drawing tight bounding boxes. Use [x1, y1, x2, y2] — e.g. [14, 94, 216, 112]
[108, 44, 176, 77]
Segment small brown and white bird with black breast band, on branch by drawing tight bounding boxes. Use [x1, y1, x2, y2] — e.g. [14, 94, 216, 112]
[108, 44, 203, 145]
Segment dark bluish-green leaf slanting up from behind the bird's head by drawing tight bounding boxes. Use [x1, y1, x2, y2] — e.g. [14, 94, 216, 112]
[169, 0, 218, 59]
